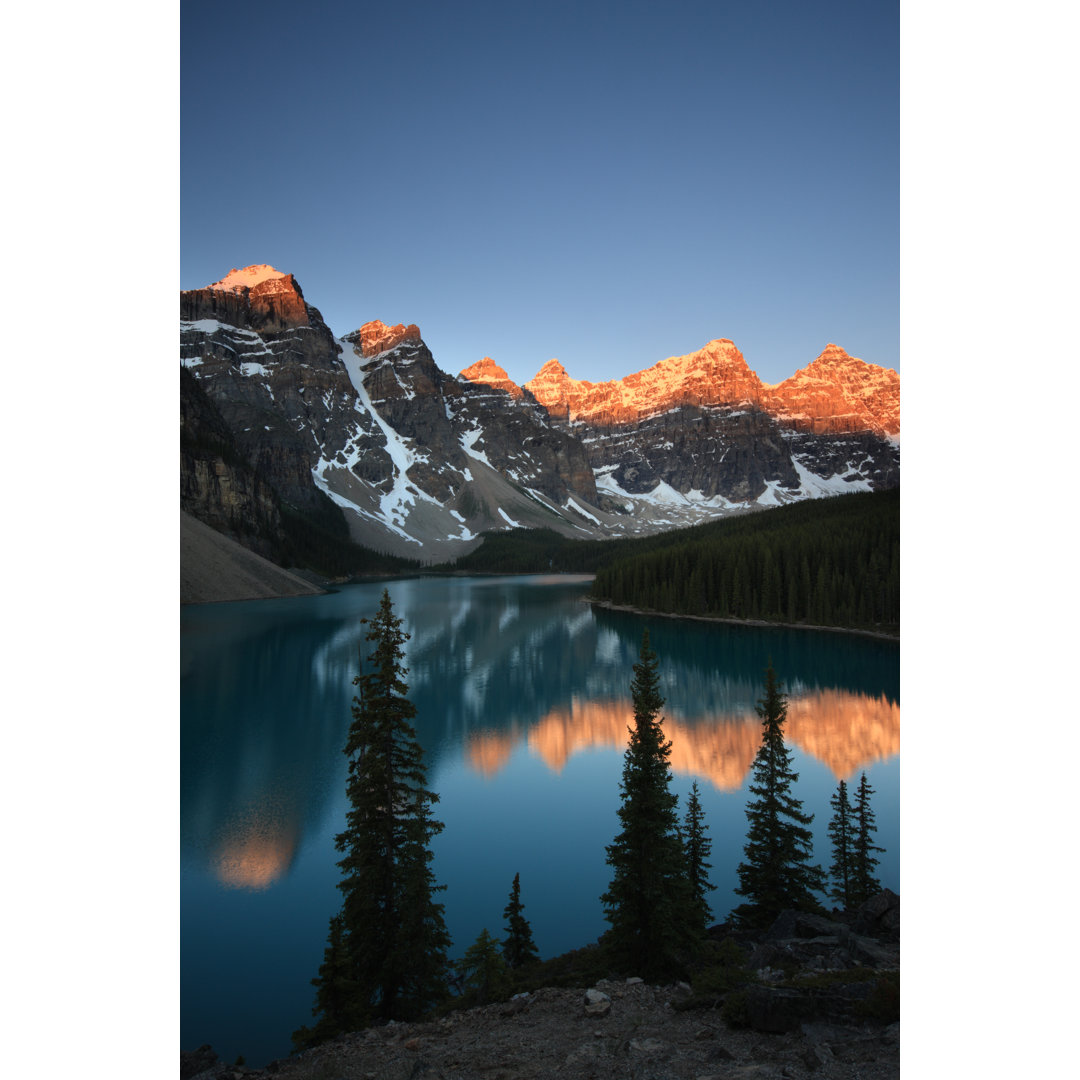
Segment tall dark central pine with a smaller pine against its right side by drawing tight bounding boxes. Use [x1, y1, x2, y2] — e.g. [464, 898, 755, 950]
[600, 631, 697, 978]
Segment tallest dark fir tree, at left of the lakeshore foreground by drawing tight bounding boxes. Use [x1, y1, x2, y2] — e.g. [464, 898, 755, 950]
[293, 591, 450, 1047]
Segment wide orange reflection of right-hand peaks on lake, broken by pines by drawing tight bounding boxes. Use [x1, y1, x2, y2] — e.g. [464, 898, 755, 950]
[467, 690, 900, 792]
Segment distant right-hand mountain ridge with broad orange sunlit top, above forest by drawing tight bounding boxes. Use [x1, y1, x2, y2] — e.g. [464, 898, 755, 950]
[501, 338, 900, 513]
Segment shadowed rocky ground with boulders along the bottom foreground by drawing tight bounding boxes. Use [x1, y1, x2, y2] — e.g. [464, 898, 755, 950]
[180, 893, 900, 1080]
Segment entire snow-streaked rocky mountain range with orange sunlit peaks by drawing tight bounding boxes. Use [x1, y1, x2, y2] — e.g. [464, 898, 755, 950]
[180, 266, 900, 561]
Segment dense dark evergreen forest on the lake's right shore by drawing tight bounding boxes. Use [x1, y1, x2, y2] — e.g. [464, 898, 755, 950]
[592, 488, 900, 631]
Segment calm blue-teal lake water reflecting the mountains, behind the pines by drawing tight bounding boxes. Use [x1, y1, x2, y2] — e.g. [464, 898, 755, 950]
[180, 577, 900, 1066]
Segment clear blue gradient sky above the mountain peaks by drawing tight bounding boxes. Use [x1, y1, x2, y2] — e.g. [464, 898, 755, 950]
[180, 0, 900, 382]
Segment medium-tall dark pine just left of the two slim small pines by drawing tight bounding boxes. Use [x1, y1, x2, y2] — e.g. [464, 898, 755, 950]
[734, 661, 825, 927]
